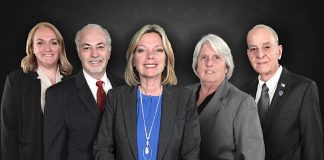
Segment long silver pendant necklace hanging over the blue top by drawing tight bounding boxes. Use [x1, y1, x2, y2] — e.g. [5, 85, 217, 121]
[138, 88, 162, 160]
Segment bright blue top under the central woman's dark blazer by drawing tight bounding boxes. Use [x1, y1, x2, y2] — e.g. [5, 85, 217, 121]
[137, 88, 162, 160]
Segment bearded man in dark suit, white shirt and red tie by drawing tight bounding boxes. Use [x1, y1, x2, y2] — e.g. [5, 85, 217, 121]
[44, 24, 123, 160]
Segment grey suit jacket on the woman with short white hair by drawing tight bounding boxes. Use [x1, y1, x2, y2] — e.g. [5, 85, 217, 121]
[188, 80, 264, 160]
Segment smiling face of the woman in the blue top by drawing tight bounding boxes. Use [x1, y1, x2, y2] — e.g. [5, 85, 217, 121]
[134, 32, 166, 81]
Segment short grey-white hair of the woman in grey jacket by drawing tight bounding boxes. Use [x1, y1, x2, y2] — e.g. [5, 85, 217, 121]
[192, 34, 234, 79]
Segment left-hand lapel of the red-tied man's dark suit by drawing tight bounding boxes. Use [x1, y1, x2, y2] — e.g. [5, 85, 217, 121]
[75, 70, 100, 119]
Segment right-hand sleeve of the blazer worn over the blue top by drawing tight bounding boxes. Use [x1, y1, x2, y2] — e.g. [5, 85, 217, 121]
[180, 89, 201, 160]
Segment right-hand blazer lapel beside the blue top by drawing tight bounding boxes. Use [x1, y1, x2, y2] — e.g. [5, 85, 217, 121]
[157, 86, 179, 160]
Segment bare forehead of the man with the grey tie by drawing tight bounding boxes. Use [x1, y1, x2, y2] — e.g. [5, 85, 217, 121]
[247, 28, 275, 45]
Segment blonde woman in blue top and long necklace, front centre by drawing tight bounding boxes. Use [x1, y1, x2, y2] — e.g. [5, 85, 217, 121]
[94, 24, 200, 160]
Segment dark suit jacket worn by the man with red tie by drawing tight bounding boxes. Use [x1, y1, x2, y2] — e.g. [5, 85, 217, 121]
[44, 70, 123, 160]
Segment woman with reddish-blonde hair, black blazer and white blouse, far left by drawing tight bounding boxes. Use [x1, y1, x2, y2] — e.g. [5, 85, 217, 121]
[1, 22, 72, 160]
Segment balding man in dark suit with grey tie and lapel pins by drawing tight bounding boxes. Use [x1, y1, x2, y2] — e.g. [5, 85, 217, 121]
[241, 24, 323, 160]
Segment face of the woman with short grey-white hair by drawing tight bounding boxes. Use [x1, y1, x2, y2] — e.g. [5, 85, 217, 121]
[197, 42, 228, 85]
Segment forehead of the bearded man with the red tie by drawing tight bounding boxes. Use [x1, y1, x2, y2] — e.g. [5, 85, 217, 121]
[80, 28, 106, 45]
